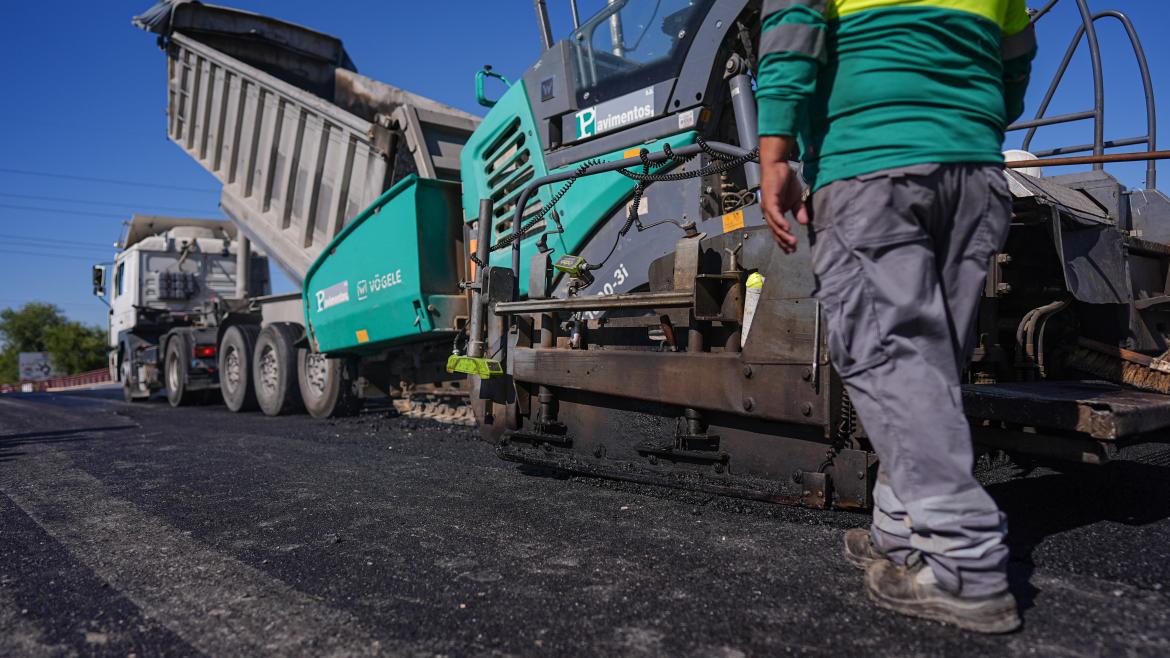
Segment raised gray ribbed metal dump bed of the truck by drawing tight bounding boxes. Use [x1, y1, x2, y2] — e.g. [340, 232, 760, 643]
[136, 2, 480, 282]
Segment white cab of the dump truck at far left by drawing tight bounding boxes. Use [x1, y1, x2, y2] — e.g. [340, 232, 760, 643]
[94, 215, 270, 405]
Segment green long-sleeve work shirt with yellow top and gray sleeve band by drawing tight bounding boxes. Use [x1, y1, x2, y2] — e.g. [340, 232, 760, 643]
[756, 0, 1035, 189]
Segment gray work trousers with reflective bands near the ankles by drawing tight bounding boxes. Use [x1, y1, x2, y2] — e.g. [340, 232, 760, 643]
[812, 164, 1011, 596]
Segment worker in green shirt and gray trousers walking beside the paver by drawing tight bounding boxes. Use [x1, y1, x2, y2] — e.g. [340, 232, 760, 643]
[757, 0, 1035, 632]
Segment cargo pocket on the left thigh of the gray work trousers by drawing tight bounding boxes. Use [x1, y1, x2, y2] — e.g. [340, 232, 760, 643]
[814, 227, 889, 378]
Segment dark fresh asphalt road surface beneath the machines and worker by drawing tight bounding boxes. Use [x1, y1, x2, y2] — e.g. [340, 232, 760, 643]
[0, 391, 1170, 657]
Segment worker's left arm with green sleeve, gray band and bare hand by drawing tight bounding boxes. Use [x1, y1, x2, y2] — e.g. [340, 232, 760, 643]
[756, 0, 826, 252]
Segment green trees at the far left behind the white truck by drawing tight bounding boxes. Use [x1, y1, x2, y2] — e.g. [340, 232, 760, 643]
[0, 302, 106, 383]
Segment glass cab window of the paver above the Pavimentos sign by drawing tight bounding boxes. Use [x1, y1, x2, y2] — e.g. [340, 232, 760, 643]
[569, 0, 714, 105]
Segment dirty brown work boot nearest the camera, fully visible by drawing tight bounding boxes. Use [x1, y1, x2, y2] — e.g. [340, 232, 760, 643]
[866, 560, 1020, 633]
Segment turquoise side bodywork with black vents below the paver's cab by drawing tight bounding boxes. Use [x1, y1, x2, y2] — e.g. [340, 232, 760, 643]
[460, 76, 696, 295]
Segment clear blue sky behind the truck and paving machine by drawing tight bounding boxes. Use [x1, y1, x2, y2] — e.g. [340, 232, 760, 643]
[0, 0, 1170, 325]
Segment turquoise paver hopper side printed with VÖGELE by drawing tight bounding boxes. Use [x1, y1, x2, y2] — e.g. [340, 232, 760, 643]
[304, 176, 467, 356]
